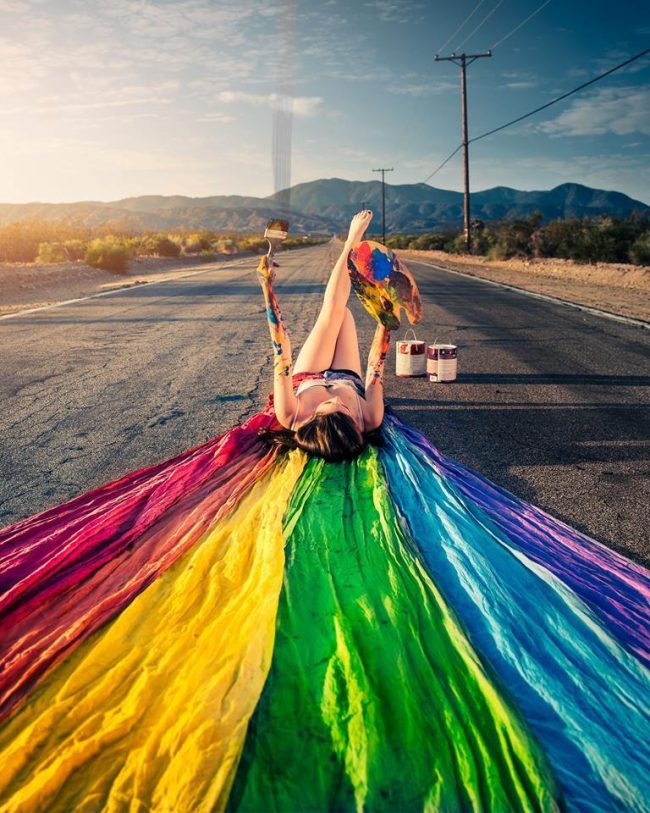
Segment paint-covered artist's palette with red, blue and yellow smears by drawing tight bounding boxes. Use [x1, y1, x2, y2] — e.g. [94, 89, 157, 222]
[348, 240, 422, 330]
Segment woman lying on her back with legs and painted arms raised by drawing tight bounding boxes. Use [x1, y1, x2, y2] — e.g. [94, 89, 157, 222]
[258, 209, 419, 460]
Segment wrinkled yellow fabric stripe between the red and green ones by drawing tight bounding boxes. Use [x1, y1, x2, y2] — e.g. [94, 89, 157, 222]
[0, 451, 306, 813]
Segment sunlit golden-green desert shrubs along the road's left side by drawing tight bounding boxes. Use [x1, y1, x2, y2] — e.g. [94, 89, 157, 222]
[0, 220, 323, 271]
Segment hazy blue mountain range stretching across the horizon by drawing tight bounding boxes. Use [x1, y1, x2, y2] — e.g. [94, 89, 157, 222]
[0, 178, 650, 234]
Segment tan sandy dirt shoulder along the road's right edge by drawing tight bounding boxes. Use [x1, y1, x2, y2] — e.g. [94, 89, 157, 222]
[397, 251, 650, 321]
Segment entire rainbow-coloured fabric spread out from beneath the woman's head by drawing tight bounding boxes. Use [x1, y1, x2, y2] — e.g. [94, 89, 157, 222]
[0, 377, 650, 813]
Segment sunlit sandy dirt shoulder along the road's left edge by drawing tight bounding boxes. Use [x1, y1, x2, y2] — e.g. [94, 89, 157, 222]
[0, 252, 252, 316]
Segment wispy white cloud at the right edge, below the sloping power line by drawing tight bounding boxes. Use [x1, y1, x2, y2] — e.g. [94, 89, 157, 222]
[536, 86, 650, 136]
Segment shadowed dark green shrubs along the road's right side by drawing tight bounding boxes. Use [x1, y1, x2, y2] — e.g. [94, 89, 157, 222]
[386, 212, 650, 265]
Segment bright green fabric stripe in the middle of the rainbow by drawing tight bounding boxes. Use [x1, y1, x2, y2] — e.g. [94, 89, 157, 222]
[228, 449, 555, 813]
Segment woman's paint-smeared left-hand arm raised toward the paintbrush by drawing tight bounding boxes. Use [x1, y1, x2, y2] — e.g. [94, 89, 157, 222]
[257, 256, 298, 428]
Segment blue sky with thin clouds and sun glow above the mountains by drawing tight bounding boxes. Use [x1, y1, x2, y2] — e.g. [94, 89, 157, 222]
[0, 0, 650, 204]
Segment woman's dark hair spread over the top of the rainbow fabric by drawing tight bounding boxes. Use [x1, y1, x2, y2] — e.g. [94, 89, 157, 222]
[258, 412, 384, 462]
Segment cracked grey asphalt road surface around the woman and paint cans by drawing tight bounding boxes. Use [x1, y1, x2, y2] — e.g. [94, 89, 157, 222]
[0, 245, 650, 564]
